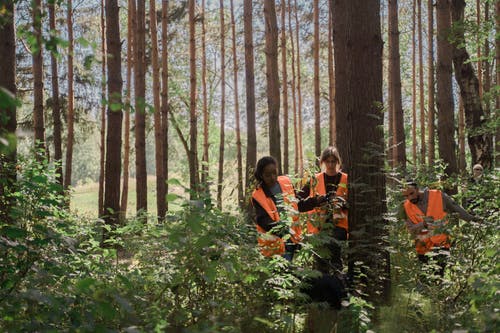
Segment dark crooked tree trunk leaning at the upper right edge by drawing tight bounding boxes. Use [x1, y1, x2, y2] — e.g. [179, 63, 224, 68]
[451, 0, 493, 169]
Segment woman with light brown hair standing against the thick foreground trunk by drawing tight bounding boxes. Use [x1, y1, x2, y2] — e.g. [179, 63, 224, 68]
[299, 146, 348, 273]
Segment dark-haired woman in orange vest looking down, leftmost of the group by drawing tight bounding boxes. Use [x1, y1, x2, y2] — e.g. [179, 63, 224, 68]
[252, 156, 302, 261]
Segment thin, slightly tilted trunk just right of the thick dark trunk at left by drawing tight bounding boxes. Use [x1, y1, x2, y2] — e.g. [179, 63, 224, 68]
[120, 0, 136, 220]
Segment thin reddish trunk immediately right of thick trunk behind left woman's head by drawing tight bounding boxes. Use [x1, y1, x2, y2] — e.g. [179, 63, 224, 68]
[281, 0, 289, 174]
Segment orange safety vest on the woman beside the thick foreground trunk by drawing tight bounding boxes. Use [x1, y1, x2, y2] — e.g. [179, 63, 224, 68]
[307, 172, 349, 234]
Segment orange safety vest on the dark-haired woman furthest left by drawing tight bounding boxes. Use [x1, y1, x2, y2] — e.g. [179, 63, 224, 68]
[252, 176, 302, 257]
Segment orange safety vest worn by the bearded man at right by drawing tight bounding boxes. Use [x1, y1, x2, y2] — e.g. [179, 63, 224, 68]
[404, 190, 450, 254]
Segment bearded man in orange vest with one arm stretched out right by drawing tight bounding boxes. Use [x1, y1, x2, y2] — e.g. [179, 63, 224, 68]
[400, 181, 477, 276]
